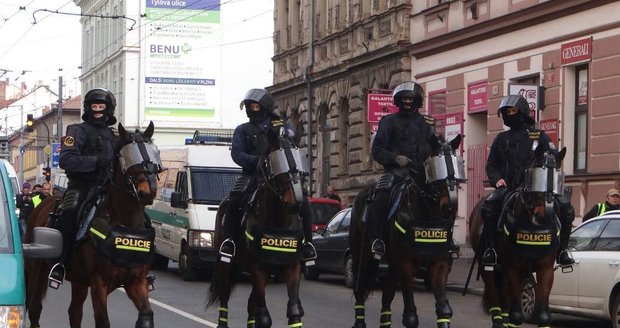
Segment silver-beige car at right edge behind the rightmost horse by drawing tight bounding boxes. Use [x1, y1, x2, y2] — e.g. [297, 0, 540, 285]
[523, 211, 620, 328]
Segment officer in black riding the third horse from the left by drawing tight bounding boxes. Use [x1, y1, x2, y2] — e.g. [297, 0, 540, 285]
[367, 81, 458, 259]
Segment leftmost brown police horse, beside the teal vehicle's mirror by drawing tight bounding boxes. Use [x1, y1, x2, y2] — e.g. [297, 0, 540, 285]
[26, 122, 161, 328]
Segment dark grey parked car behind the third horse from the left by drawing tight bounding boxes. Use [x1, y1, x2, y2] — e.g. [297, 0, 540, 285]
[304, 207, 430, 289]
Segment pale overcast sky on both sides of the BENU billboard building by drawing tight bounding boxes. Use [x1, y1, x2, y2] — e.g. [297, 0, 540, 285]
[0, 0, 273, 127]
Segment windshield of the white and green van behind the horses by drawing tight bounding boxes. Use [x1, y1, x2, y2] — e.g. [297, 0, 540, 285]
[191, 167, 241, 205]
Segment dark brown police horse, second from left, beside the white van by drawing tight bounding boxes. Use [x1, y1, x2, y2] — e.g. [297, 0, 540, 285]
[207, 133, 307, 328]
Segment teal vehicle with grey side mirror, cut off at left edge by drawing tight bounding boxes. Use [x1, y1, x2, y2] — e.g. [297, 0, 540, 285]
[0, 160, 62, 327]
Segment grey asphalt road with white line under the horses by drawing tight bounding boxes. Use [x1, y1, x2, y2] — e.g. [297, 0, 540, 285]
[29, 267, 611, 328]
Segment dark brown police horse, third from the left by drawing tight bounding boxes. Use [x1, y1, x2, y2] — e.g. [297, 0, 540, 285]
[349, 135, 465, 328]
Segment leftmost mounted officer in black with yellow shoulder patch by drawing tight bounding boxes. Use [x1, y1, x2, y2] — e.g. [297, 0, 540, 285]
[49, 88, 118, 288]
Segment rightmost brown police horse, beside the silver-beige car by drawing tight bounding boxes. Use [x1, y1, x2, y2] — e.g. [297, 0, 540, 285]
[469, 146, 566, 328]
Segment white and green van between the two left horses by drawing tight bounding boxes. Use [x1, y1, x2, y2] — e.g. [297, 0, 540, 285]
[146, 130, 241, 281]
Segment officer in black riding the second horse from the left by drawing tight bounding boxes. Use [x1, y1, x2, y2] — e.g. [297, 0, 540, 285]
[220, 89, 316, 262]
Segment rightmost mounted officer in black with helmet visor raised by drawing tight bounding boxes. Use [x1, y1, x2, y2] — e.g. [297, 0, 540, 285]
[481, 95, 575, 266]
